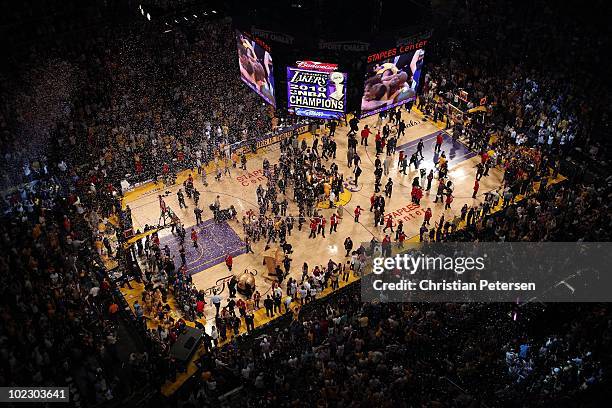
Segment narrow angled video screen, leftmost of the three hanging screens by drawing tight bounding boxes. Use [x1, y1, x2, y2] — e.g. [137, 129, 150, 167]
[236, 30, 276, 107]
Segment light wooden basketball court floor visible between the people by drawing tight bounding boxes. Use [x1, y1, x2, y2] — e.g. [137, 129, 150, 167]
[124, 111, 502, 324]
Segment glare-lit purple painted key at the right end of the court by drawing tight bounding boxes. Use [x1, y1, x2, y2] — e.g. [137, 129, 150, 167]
[397, 130, 476, 168]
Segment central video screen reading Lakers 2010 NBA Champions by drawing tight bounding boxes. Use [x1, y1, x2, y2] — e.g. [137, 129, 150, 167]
[287, 61, 347, 119]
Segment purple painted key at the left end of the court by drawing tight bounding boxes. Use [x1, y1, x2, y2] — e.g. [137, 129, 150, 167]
[160, 219, 246, 275]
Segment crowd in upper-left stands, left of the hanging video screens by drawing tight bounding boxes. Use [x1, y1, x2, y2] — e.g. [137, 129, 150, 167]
[2, 16, 272, 192]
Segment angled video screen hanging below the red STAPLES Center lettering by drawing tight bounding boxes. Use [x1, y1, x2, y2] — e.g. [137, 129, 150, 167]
[361, 45, 425, 117]
